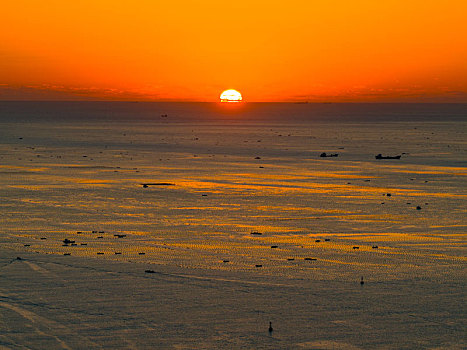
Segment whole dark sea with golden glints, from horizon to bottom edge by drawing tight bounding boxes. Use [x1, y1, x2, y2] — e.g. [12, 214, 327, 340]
[0, 102, 467, 349]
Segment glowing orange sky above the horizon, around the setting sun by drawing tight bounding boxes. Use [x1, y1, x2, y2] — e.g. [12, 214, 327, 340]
[0, 0, 467, 102]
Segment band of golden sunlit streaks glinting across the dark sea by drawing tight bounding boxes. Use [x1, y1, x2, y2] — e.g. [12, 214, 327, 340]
[0, 121, 466, 279]
